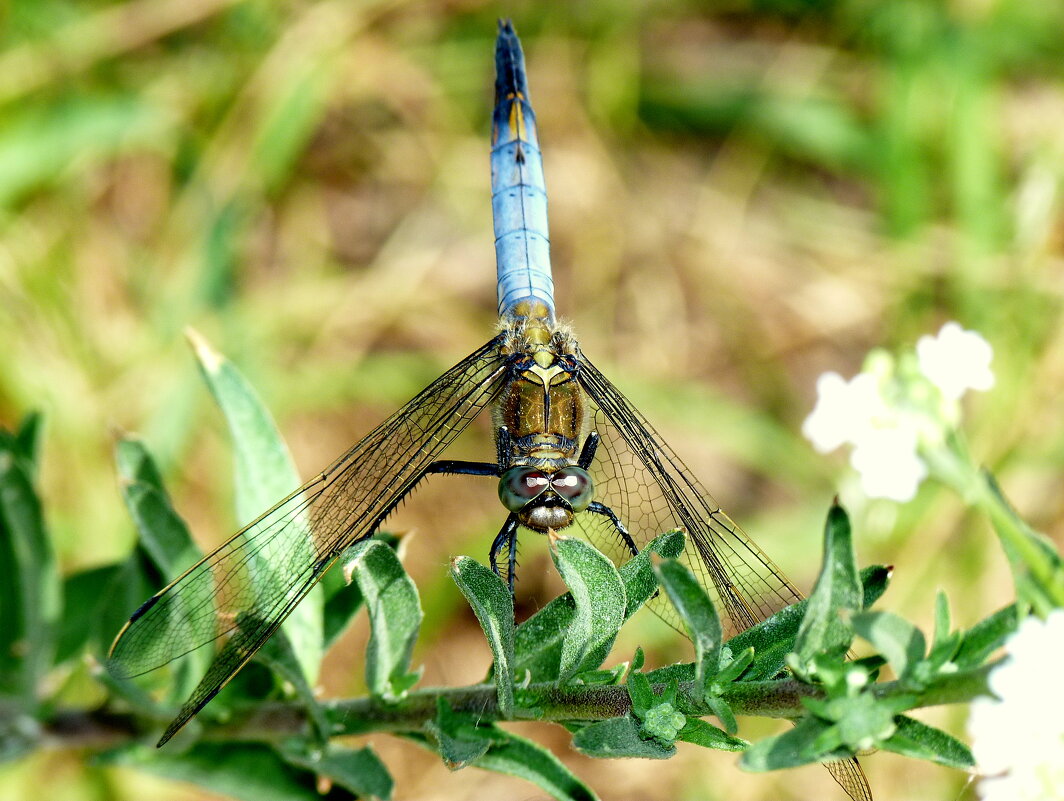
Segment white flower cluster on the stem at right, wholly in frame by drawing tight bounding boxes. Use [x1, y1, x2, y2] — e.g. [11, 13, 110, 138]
[802, 322, 994, 501]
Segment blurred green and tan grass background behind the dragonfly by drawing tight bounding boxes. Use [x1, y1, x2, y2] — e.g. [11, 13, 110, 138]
[0, 0, 1064, 799]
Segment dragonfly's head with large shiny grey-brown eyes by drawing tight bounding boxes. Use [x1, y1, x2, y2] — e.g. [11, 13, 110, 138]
[499, 466, 595, 531]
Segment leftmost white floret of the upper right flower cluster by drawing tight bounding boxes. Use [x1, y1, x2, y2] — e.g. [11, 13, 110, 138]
[801, 372, 884, 453]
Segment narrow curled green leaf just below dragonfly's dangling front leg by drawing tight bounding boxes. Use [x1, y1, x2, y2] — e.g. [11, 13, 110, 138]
[451, 556, 514, 718]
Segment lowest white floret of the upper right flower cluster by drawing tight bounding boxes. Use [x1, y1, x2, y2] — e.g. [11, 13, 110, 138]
[850, 428, 928, 503]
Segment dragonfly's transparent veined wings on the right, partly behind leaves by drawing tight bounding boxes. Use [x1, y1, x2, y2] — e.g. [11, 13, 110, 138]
[577, 356, 871, 801]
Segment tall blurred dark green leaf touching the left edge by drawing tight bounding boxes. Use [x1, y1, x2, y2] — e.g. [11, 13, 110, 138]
[0, 439, 63, 706]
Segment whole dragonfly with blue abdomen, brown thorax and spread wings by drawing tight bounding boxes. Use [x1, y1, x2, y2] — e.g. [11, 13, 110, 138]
[109, 20, 871, 799]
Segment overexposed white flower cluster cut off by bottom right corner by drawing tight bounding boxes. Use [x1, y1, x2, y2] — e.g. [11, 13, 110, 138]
[968, 610, 1064, 801]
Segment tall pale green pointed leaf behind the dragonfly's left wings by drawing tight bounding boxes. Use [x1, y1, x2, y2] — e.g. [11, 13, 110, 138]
[187, 329, 325, 685]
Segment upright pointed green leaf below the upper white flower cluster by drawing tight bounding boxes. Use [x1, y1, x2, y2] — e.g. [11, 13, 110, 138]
[794, 504, 863, 665]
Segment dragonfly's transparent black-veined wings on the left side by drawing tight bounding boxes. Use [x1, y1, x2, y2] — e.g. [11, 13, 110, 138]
[107, 337, 506, 745]
